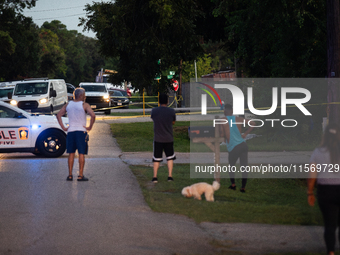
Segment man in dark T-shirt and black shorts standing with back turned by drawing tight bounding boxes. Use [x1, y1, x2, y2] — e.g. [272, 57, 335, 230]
[151, 94, 176, 183]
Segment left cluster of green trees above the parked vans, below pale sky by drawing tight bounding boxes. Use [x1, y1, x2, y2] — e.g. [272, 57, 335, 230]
[0, 1, 108, 85]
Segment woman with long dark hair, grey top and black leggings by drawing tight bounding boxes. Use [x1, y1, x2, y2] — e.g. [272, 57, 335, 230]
[307, 123, 340, 255]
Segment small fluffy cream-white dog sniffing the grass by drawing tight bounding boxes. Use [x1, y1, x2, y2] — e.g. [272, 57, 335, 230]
[182, 181, 220, 202]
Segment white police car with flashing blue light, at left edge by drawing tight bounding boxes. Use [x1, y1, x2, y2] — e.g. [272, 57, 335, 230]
[0, 102, 68, 157]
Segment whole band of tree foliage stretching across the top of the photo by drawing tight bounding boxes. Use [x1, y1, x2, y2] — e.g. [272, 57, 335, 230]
[0, 0, 326, 86]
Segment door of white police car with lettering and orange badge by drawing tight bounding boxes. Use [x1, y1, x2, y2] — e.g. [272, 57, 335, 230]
[0, 105, 33, 150]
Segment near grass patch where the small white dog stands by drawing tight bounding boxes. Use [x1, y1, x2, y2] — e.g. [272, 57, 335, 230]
[130, 164, 322, 225]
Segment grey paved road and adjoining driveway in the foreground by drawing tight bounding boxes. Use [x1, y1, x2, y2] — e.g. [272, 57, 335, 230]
[0, 121, 325, 255]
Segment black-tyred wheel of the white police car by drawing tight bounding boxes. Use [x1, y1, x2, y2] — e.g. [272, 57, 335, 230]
[37, 130, 66, 158]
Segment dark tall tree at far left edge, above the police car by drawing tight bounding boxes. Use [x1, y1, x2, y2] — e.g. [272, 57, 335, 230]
[0, 0, 41, 80]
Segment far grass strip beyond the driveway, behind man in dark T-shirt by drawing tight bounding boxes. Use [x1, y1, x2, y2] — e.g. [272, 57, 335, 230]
[111, 121, 320, 152]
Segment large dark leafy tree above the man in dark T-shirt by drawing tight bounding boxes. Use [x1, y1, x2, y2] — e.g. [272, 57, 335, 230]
[81, 0, 202, 89]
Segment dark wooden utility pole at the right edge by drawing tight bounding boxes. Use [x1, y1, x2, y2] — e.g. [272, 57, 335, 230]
[327, 0, 340, 124]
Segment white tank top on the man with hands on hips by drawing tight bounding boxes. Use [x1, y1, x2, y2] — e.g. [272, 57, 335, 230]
[66, 101, 86, 132]
